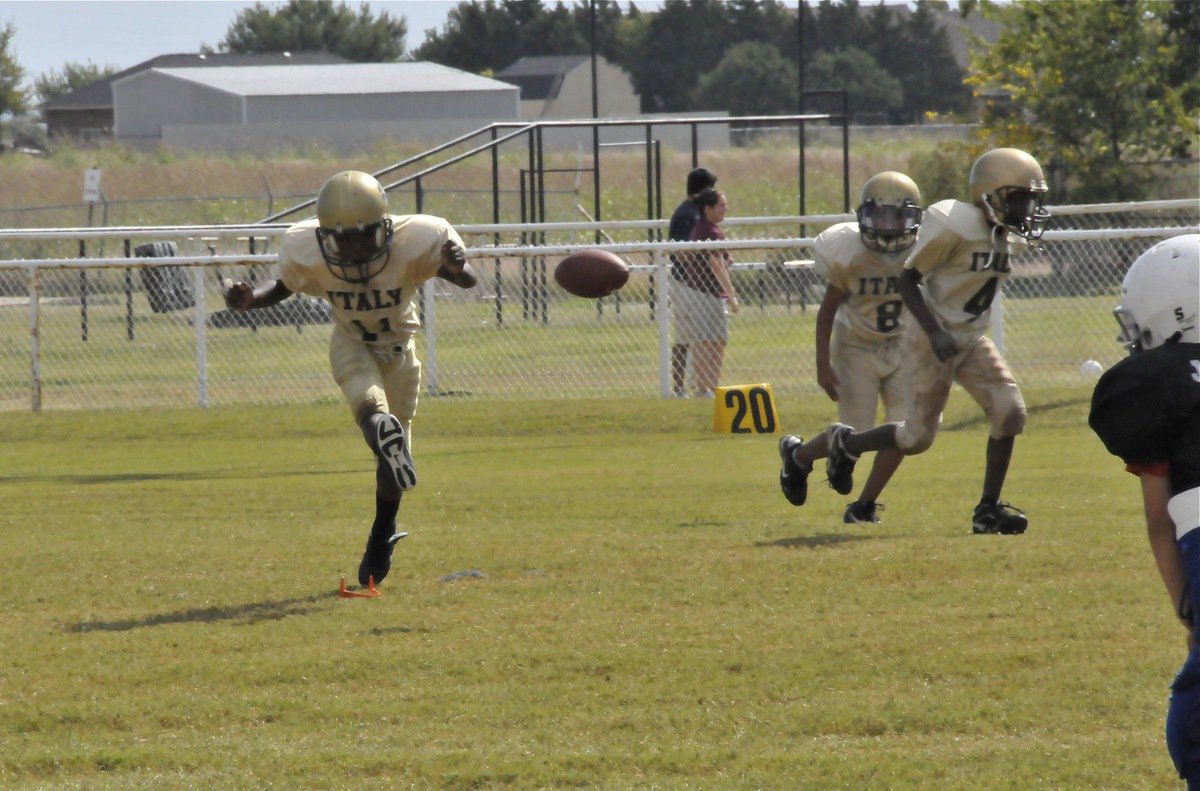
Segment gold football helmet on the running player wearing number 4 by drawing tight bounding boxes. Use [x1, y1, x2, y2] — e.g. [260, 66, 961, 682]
[967, 149, 1050, 241]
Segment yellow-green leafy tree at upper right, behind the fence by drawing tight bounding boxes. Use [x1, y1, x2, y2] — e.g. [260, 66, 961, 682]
[968, 0, 1198, 200]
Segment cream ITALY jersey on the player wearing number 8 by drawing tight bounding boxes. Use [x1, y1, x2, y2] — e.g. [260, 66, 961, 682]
[812, 222, 908, 342]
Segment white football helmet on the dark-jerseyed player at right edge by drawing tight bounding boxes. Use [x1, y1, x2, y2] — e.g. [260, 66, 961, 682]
[1112, 234, 1200, 352]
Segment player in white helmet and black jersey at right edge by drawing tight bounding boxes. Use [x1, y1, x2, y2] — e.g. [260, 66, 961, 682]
[1087, 234, 1200, 789]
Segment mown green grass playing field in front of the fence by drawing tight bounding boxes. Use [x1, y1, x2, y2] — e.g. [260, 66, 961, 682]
[0, 389, 1184, 789]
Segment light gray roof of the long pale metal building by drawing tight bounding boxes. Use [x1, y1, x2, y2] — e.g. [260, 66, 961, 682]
[137, 61, 511, 96]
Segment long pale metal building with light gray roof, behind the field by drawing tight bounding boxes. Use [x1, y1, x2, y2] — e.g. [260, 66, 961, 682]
[113, 62, 520, 152]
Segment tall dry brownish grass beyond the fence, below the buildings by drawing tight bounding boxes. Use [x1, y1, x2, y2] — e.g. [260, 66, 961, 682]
[0, 137, 955, 227]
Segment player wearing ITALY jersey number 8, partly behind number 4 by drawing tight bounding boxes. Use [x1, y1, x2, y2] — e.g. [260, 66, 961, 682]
[779, 170, 920, 525]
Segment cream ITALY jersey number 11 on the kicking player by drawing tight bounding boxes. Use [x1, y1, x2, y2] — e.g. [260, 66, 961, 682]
[275, 215, 466, 346]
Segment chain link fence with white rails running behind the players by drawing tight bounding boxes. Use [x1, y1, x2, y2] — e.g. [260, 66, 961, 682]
[0, 200, 1200, 411]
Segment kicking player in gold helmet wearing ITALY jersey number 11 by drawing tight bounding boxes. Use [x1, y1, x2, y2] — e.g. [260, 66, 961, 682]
[224, 170, 475, 585]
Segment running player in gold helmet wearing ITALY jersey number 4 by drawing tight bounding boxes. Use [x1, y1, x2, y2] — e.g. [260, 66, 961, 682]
[826, 149, 1050, 534]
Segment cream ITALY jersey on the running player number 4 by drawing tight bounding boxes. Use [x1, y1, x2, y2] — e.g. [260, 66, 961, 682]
[905, 200, 1026, 342]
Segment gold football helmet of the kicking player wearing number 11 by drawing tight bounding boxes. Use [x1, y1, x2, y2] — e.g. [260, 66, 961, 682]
[317, 170, 392, 286]
